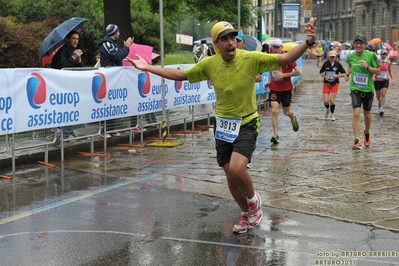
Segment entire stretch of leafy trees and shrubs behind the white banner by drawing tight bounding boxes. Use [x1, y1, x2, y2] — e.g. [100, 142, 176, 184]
[0, 0, 255, 67]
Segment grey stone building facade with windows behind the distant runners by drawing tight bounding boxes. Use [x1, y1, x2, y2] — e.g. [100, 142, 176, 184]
[252, 0, 399, 45]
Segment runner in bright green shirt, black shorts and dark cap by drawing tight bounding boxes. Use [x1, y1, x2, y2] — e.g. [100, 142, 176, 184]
[345, 35, 381, 150]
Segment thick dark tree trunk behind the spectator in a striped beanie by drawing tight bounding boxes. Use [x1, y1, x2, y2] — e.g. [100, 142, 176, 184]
[103, 0, 133, 46]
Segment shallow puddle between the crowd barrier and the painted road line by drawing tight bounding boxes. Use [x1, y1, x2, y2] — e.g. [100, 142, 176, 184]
[0, 165, 121, 217]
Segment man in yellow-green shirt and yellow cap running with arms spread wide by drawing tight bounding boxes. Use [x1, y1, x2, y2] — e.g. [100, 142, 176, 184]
[125, 18, 316, 233]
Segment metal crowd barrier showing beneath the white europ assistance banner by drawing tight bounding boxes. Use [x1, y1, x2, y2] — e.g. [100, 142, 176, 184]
[0, 76, 302, 172]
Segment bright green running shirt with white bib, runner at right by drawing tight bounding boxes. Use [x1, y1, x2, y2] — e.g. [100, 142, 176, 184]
[348, 50, 379, 92]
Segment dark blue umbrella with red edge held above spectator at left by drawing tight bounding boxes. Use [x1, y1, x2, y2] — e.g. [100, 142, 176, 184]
[39, 17, 87, 66]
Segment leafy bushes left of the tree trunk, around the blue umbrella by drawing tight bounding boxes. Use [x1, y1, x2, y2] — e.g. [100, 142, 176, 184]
[0, 0, 103, 67]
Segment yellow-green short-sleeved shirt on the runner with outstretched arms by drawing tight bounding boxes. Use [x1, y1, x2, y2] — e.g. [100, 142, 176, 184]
[184, 49, 280, 125]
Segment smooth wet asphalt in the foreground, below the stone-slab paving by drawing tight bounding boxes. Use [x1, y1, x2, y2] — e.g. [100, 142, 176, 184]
[0, 167, 399, 266]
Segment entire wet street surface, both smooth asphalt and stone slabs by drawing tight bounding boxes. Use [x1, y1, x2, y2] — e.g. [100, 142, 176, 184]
[0, 59, 399, 266]
